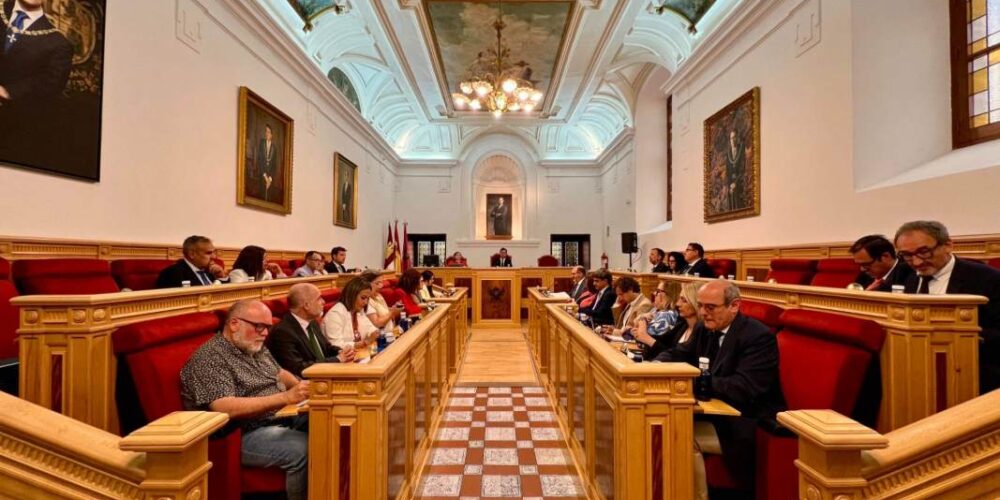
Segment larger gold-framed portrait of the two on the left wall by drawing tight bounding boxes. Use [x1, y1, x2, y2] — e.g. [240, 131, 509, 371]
[236, 87, 295, 215]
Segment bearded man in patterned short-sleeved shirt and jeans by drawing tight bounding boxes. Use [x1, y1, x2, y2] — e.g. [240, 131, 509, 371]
[181, 300, 309, 499]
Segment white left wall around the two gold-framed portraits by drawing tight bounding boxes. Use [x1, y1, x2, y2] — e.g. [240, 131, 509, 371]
[0, 0, 395, 266]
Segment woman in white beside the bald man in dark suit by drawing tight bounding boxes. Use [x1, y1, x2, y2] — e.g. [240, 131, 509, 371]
[323, 277, 379, 351]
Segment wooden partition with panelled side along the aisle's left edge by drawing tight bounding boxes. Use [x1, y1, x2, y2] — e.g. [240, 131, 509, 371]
[303, 290, 468, 500]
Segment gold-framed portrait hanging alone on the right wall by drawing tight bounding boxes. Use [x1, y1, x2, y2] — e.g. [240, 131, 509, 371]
[705, 87, 760, 223]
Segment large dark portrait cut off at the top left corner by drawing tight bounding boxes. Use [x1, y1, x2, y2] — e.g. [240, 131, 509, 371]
[0, 0, 106, 181]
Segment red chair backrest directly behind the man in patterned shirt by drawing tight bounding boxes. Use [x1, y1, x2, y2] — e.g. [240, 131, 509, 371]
[113, 312, 221, 421]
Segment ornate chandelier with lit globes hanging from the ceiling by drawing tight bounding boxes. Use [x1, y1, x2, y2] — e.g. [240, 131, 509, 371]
[452, 0, 542, 118]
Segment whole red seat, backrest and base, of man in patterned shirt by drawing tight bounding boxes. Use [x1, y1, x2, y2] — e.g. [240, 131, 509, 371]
[113, 312, 285, 500]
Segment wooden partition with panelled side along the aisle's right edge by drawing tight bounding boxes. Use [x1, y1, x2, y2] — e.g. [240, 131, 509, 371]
[529, 289, 698, 500]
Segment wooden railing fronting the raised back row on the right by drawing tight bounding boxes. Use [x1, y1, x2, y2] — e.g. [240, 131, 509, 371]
[617, 273, 986, 432]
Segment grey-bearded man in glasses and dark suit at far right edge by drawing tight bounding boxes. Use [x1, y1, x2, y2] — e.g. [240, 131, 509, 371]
[895, 221, 1000, 394]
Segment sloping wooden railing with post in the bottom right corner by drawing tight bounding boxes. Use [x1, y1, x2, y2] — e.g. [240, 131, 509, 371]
[778, 390, 1000, 500]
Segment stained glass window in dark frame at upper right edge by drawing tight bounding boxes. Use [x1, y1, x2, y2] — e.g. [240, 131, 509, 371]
[952, 0, 1000, 146]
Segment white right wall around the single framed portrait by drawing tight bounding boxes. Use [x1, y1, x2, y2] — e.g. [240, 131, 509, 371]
[636, 0, 1000, 254]
